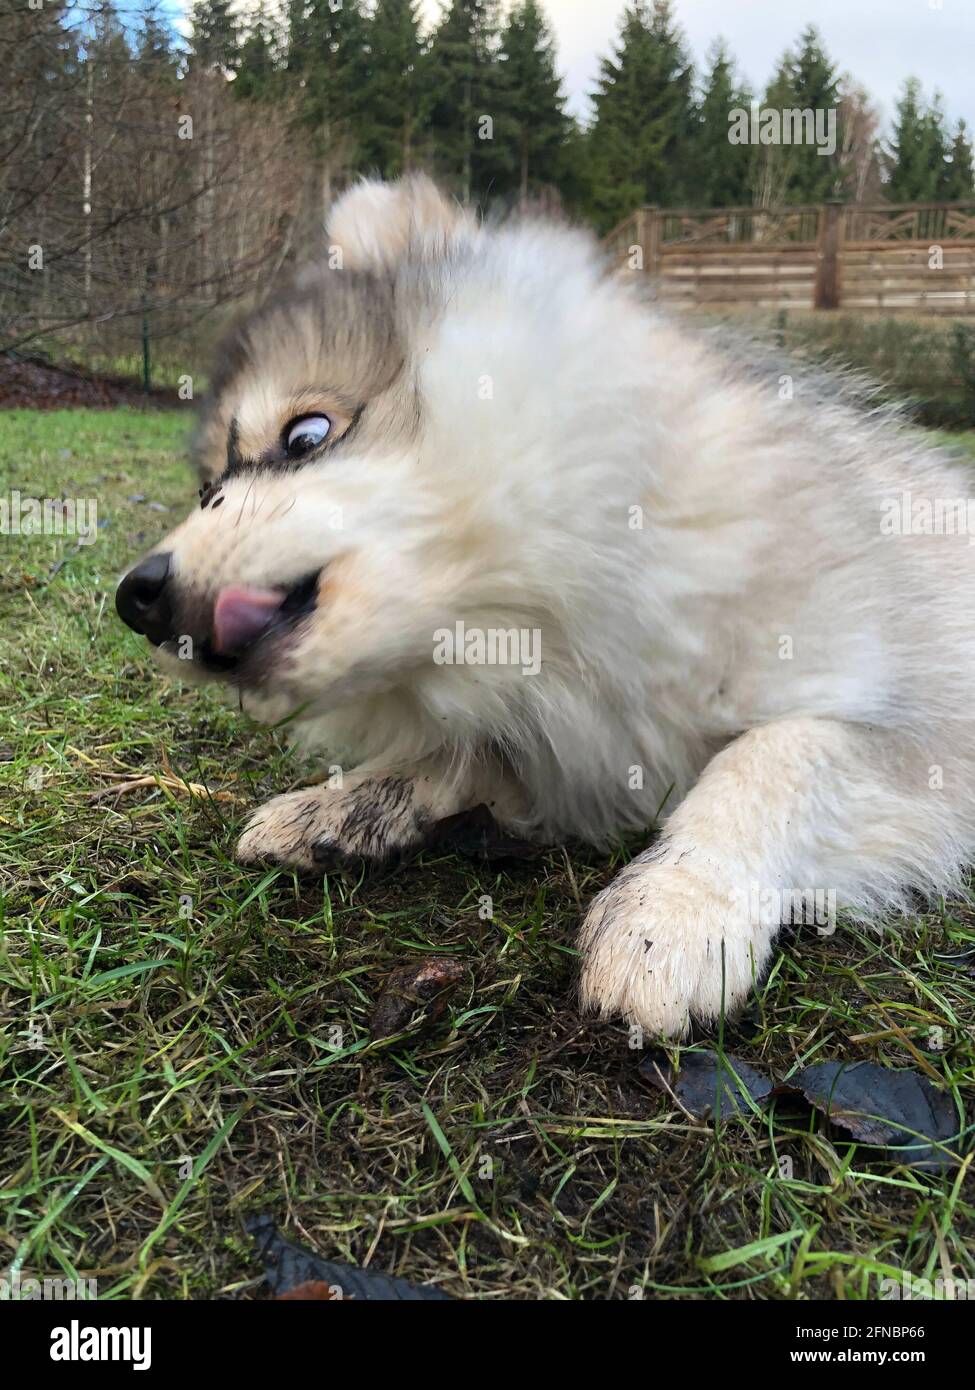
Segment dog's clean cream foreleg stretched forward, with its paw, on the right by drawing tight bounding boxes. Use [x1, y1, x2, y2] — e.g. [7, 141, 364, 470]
[581, 719, 971, 1036]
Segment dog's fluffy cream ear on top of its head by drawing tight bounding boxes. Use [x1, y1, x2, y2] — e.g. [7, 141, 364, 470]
[328, 174, 477, 270]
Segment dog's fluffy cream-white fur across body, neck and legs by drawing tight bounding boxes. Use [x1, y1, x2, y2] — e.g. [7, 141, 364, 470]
[144, 182, 975, 1034]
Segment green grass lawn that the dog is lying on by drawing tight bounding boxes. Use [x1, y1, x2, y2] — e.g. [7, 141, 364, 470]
[0, 410, 975, 1300]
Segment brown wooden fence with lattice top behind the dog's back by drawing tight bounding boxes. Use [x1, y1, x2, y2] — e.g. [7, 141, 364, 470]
[605, 202, 975, 314]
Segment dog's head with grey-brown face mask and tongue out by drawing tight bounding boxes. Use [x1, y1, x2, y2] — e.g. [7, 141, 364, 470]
[117, 178, 639, 713]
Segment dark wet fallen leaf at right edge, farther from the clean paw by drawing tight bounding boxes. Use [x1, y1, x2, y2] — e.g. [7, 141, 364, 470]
[776, 1062, 958, 1169]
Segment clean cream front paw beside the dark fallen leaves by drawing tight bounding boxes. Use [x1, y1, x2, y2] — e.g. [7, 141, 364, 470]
[580, 859, 771, 1037]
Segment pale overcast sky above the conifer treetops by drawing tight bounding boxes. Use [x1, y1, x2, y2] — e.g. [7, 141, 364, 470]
[423, 0, 975, 128]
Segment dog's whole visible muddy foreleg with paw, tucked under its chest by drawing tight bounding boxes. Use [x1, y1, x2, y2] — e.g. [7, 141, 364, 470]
[236, 759, 515, 872]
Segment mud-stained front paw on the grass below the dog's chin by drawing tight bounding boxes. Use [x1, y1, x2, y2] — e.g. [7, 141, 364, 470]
[236, 777, 426, 873]
